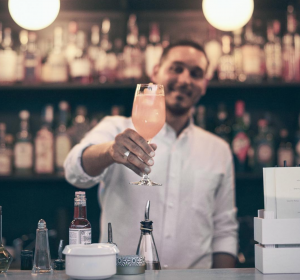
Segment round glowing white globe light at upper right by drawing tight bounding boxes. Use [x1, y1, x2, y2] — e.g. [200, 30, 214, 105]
[202, 0, 254, 31]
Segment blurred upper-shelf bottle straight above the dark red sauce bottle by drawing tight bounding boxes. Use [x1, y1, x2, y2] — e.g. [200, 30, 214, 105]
[70, 30, 91, 84]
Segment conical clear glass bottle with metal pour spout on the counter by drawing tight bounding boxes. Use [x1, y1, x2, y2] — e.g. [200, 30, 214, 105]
[136, 200, 161, 270]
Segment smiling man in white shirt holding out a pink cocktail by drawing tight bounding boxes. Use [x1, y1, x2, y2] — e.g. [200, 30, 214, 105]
[65, 41, 238, 269]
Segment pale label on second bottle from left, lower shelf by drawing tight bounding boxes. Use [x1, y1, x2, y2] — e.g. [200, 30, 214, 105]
[14, 143, 33, 168]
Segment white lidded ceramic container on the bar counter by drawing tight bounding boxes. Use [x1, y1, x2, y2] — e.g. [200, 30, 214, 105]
[63, 243, 119, 279]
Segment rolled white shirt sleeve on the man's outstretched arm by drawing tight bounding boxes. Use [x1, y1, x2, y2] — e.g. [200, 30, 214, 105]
[64, 117, 121, 188]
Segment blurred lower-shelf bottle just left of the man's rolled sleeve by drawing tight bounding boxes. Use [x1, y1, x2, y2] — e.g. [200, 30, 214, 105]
[55, 101, 72, 174]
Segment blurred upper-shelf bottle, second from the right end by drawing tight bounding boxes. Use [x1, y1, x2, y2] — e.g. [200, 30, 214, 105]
[265, 20, 282, 81]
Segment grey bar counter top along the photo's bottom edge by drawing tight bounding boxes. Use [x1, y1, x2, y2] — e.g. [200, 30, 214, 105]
[0, 268, 300, 280]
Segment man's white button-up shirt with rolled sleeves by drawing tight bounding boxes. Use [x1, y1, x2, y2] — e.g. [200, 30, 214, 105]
[65, 117, 237, 269]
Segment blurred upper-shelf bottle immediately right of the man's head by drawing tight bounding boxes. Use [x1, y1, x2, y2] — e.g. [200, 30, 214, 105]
[204, 25, 222, 80]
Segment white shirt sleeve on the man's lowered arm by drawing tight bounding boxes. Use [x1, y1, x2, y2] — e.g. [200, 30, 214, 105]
[212, 147, 238, 256]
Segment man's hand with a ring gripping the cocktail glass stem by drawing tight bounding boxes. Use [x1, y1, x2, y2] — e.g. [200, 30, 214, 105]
[108, 128, 157, 176]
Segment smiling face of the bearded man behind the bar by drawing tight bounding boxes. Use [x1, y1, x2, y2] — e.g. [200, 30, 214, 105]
[152, 46, 208, 115]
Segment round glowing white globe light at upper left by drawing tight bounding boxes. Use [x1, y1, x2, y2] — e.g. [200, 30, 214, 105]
[8, 0, 60, 30]
